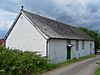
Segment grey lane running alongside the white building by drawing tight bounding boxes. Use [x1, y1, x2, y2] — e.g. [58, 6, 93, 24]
[42, 56, 100, 75]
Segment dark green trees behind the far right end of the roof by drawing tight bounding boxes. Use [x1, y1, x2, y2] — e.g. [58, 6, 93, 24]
[79, 27, 100, 49]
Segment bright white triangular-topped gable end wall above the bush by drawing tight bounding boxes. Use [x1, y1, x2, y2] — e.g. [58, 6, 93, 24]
[6, 15, 46, 56]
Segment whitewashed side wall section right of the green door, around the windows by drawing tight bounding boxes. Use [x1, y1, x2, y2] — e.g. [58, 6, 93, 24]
[72, 40, 94, 58]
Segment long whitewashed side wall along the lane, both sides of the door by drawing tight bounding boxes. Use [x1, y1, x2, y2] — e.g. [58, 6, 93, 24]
[48, 39, 94, 63]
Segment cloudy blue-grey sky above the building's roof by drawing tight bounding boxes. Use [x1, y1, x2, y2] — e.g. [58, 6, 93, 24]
[0, 0, 100, 37]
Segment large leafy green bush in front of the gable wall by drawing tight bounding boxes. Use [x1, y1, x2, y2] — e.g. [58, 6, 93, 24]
[0, 47, 47, 75]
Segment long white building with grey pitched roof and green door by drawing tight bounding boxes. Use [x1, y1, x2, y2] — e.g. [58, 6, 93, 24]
[5, 10, 94, 63]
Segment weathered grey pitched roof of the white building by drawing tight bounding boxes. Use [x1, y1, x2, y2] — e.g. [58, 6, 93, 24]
[6, 10, 93, 40]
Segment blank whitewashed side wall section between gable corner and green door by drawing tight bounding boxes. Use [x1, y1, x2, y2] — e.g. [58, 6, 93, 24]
[48, 39, 67, 63]
